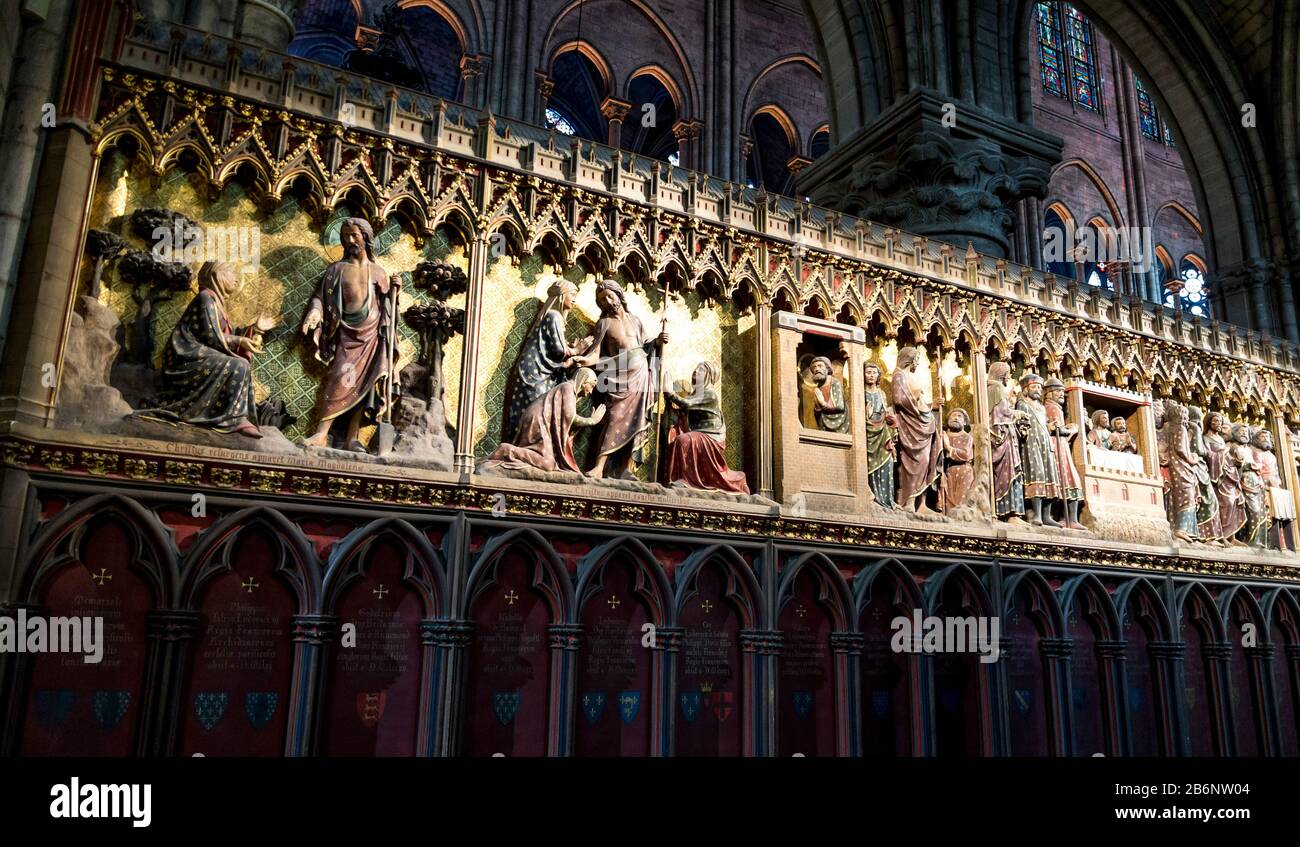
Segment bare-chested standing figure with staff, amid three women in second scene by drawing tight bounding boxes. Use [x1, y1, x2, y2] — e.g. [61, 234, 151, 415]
[571, 279, 668, 479]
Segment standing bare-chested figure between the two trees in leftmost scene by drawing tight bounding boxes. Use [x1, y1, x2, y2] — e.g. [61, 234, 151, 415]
[303, 218, 400, 452]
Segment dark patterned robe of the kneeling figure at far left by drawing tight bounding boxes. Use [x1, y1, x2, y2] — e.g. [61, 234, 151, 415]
[138, 290, 256, 433]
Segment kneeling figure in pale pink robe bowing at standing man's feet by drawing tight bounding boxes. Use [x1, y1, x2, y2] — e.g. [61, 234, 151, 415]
[480, 368, 605, 473]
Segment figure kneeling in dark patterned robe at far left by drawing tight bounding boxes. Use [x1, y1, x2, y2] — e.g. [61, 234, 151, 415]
[138, 261, 276, 438]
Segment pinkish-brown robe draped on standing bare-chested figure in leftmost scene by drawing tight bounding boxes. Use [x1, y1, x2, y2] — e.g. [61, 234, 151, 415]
[308, 261, 393, 422]
